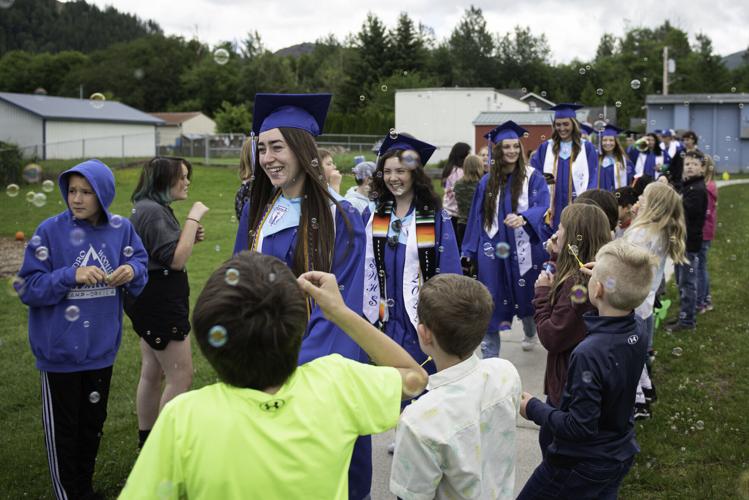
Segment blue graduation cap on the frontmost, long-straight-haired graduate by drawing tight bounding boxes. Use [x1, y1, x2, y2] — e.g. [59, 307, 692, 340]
[252, 94, 332, 136]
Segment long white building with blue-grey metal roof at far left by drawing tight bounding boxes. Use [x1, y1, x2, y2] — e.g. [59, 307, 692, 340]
[0, 92, 164, 160]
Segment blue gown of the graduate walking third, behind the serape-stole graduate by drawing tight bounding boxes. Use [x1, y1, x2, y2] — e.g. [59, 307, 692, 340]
[462, 170, 549, 332]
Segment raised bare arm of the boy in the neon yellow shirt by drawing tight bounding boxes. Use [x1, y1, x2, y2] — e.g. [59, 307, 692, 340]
[297, 271, 428, 399]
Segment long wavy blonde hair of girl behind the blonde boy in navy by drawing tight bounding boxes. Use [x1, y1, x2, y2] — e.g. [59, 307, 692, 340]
[627, 182, 687, 264]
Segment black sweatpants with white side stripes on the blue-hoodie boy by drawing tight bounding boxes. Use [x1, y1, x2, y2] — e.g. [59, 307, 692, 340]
[41, 366, 112, 500]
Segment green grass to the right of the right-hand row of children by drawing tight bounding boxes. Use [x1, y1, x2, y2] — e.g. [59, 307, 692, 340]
[621, 185, 749, 499]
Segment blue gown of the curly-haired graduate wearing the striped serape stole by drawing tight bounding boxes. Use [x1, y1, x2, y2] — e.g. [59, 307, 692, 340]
[374, 206, 463, 374]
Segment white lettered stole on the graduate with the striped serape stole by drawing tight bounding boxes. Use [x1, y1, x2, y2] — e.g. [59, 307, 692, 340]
[363, 213, 422, 329]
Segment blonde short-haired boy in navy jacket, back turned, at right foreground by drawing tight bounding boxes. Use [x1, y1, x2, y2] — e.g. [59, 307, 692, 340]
[518, 239, 654, 499]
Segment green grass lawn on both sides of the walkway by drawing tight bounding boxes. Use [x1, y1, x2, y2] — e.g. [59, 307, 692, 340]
[0, 163, 749, 498]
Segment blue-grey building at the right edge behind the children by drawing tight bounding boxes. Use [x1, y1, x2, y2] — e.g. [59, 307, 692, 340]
[645, 93, 749, 172]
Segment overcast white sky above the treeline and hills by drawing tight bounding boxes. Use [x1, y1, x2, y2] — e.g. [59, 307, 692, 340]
[77, 0, 749, 62]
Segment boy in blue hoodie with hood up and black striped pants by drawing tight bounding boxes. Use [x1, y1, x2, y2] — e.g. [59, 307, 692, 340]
[15, 160, 148, 499]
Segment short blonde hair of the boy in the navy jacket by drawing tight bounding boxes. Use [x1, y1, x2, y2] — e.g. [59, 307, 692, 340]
[591, 238, 657, 311]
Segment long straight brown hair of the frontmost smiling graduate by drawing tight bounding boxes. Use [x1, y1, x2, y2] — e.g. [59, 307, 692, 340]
[248, 127, 353, 276]
